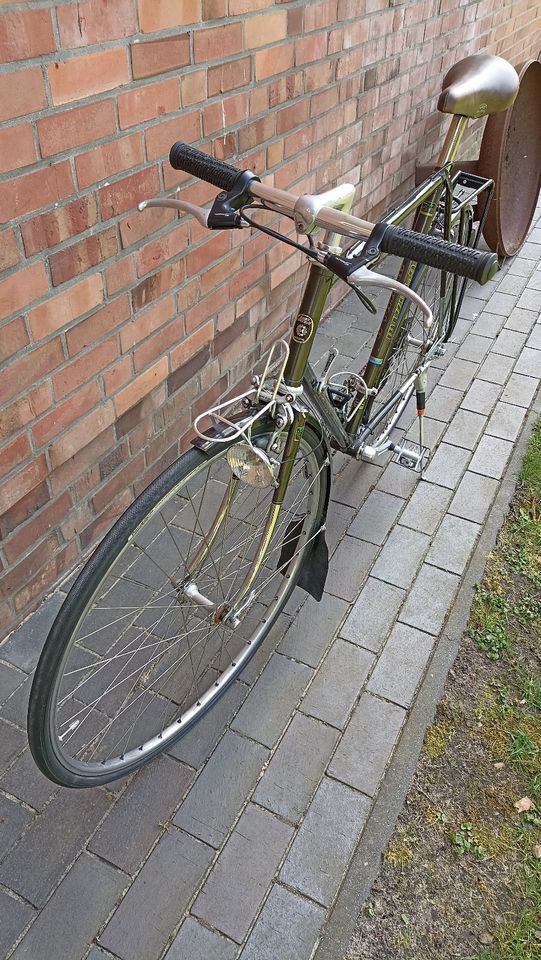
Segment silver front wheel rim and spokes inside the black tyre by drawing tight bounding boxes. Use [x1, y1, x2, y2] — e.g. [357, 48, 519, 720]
[48, 438, 323, 779]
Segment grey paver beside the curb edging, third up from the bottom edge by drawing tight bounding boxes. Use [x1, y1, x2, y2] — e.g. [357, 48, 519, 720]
[329, 693, 406, 797]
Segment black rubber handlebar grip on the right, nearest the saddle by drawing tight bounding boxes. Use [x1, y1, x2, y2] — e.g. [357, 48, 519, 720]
[379, 225, 500, 283]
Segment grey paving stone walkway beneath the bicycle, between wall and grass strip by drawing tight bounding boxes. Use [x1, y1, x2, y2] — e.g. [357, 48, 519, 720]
[0, 208, 541, 960]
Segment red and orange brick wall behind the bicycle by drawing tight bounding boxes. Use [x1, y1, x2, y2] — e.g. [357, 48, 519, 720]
[0, 0, 541, 636]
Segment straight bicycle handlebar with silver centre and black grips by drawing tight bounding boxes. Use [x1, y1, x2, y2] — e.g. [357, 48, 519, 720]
[169, 141, 499, 283]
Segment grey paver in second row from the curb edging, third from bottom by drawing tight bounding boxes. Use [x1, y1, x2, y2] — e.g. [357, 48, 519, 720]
[254, 713, 338, 823]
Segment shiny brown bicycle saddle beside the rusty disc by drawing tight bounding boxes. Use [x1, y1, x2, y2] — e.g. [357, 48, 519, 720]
[438, 53, 519, 117]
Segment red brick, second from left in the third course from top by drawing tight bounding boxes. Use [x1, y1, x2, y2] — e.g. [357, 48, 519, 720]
[37, 100, 115, 157]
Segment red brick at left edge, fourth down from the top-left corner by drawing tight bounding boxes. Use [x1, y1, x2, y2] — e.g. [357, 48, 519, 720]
[0, 160, 74, 223]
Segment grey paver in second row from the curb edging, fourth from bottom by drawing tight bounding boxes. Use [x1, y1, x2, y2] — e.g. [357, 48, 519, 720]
[301, 637, 374, 728]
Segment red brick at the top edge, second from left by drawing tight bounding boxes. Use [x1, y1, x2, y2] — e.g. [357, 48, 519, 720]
[56, 0, 137, 50]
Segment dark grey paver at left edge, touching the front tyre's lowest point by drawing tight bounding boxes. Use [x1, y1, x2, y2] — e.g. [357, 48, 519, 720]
[0, 790, 111, 907]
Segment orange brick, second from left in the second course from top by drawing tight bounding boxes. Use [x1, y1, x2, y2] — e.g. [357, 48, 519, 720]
[47, 47, 130, 104]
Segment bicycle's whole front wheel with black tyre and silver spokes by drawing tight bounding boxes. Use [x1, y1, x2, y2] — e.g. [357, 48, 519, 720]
[28, 426, 330, 787]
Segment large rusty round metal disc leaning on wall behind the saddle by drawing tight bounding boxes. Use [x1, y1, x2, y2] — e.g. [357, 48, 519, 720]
[478, 60, 541, 257]
